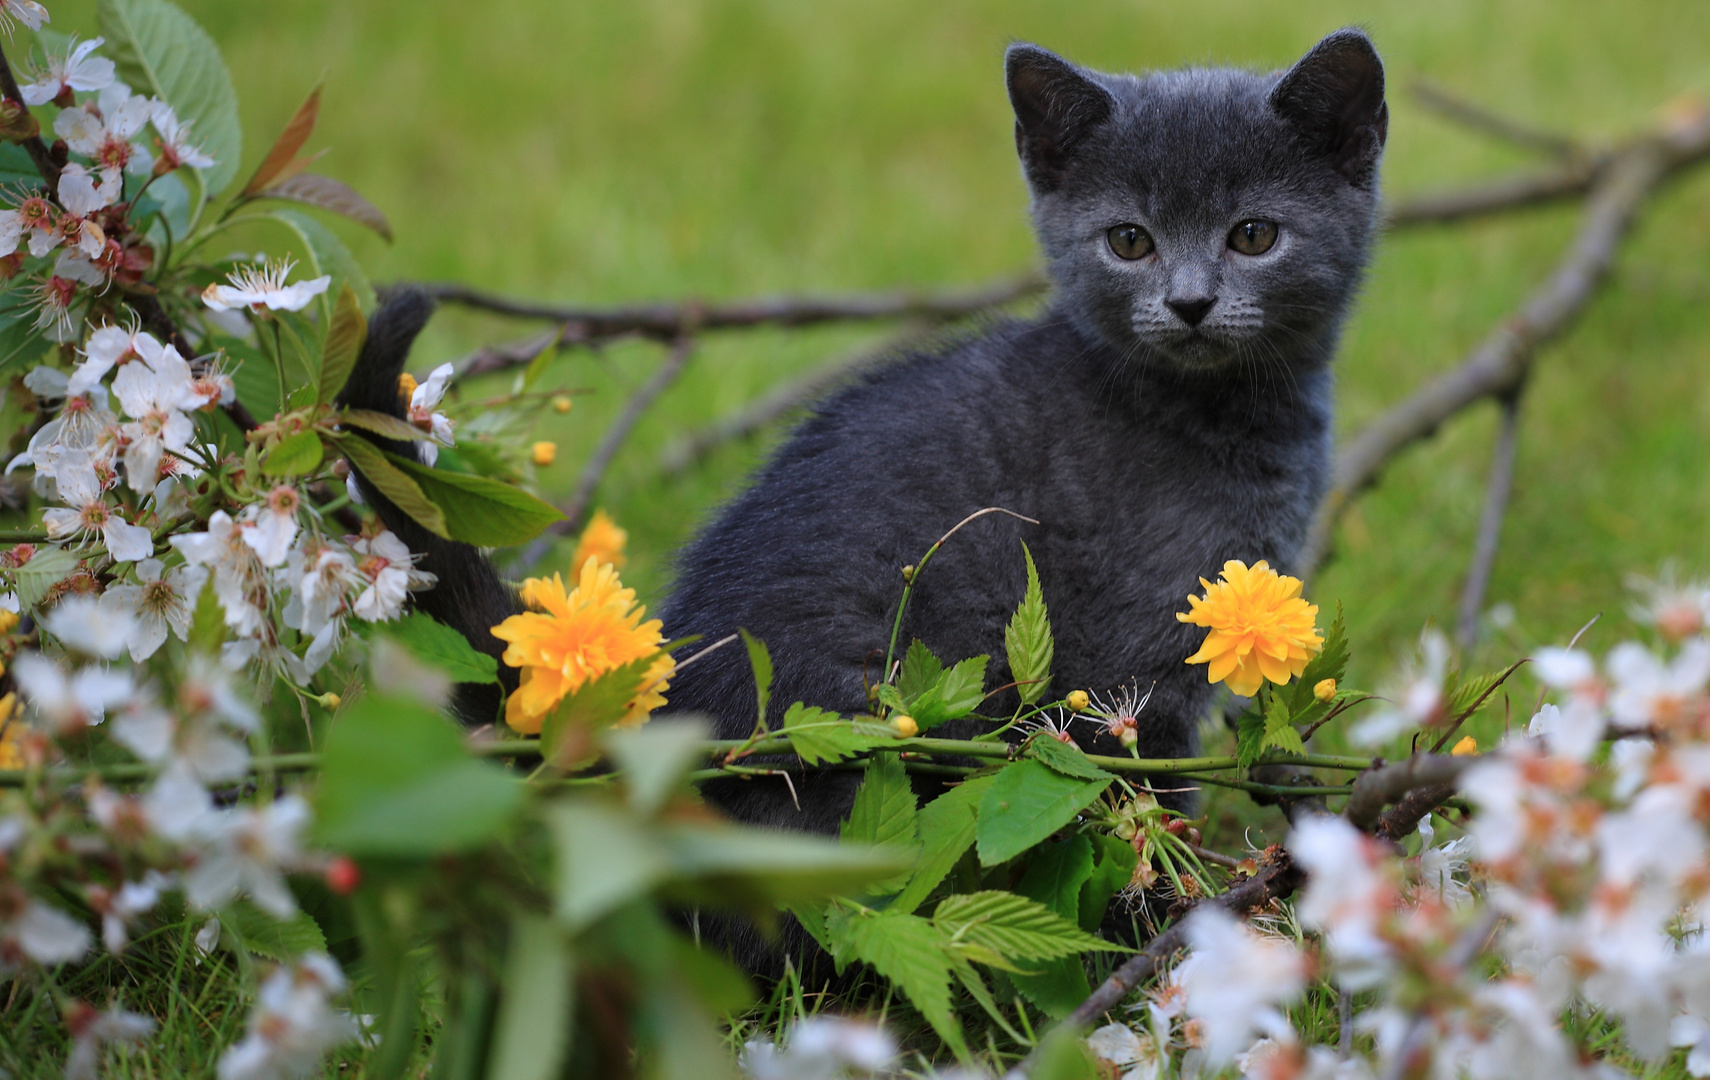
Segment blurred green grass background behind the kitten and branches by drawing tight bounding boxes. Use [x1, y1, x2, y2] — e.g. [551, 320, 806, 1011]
[40, 0, 1710, 717]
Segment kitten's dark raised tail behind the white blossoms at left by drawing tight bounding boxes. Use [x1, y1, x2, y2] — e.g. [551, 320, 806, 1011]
[339, 285, 522, 725]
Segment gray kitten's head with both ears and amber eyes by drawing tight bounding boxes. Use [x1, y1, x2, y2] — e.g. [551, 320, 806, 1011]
[1005, 29, 1389, 371]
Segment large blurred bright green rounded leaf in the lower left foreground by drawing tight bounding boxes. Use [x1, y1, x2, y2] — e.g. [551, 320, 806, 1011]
[315, 694, 523, 856]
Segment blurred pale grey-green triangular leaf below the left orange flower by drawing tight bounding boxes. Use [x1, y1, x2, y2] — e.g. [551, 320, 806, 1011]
[545, 800, 670, 933]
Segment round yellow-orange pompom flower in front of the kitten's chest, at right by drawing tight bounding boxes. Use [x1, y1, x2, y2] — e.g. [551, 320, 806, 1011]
[1176, 559, 1324, 697]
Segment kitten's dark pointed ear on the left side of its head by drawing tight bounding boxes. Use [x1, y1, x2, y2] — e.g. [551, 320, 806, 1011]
[1004, 44, 1115, 191]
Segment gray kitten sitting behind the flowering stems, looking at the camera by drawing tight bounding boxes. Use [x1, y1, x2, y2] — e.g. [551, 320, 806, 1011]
[662, 29, 1389, 844]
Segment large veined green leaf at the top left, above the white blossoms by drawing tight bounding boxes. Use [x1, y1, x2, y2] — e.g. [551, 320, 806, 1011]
[96, 0, 243, 195]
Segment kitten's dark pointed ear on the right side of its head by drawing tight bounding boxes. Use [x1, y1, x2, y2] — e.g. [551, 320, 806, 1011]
[1271, 27, 1389, 188]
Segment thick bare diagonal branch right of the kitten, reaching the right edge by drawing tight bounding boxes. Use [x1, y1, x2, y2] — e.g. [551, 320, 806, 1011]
[1300, 96, 1710, 576]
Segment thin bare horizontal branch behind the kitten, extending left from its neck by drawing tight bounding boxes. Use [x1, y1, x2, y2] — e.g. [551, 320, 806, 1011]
[422, 273, 1045, 343]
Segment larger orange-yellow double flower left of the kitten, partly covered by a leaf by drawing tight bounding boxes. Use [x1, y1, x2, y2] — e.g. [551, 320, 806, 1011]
[492, 557, 674, 735]
